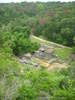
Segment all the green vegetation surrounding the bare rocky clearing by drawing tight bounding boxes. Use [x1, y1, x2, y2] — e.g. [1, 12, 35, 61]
[0, 2, 75, 100]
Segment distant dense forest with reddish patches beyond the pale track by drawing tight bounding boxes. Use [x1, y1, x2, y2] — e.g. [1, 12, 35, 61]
[0, 2, 75, 46]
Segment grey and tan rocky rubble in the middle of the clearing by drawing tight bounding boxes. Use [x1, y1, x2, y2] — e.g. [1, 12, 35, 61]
[19, 44, 63, 67]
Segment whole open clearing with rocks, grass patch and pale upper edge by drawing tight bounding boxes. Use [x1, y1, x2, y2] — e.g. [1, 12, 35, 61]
[19, 35, 72, 69]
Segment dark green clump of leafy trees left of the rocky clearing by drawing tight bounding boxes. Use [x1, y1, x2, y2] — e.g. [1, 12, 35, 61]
[1, 25, 40, 55]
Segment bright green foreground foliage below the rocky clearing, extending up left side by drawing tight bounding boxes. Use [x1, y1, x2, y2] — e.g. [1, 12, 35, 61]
[0, 49, 75, 100]
